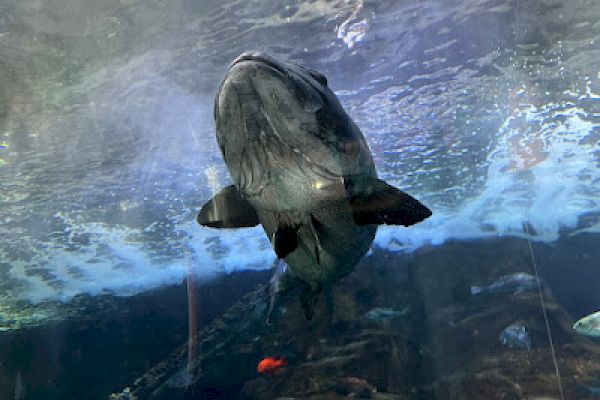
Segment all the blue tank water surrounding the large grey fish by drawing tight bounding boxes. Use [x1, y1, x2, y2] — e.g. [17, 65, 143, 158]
[0, 0, 600, 399]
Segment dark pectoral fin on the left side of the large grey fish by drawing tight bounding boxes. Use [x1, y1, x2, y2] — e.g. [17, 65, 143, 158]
[196, 185, 260, 228]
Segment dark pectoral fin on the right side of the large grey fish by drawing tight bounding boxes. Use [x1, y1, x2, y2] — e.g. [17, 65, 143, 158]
[345, 177, 431, 226]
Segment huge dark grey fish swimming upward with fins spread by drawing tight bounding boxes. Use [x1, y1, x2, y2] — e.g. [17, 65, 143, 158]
[198, 52, 431, 319]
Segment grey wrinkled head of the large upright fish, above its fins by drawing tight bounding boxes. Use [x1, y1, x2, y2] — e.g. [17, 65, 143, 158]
[214, 52, 374, 198]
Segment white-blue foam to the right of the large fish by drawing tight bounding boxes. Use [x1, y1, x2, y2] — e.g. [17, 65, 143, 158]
[375, 93, 600, 251]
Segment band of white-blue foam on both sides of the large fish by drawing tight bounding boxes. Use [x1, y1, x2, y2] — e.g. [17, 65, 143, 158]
[5, 86, 600, 303]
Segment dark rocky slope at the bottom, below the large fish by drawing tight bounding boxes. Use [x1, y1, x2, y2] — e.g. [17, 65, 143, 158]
[112, 234, 600, 400]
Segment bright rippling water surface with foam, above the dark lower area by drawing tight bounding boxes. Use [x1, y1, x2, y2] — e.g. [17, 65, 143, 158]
[0, 0, 600, 329]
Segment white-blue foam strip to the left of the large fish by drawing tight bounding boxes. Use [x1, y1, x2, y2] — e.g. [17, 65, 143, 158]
[3, 215, 274, 303]
